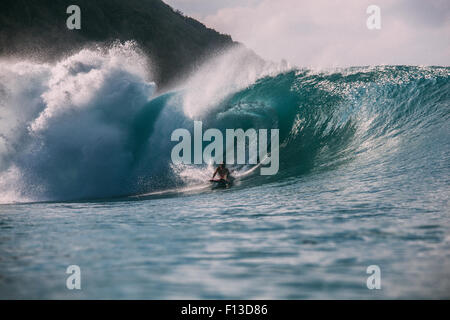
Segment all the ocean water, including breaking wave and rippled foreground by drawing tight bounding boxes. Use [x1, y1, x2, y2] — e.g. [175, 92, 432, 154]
[0, 43, 450, 299]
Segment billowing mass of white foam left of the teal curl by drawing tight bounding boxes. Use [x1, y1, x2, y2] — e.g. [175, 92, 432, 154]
[0, 42, 155, 203]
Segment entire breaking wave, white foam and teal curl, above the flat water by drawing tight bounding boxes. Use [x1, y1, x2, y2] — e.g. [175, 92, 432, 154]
[0, 44, 450, 202]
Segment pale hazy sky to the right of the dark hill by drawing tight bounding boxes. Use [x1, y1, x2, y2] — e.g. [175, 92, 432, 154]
[164, 0, 450, 67]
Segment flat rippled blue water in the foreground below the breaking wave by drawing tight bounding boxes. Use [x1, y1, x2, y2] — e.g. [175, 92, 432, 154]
[0, 159, 450, 299]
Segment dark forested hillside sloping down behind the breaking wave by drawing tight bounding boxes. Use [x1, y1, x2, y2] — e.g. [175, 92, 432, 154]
[0, 0, 237, 86]
